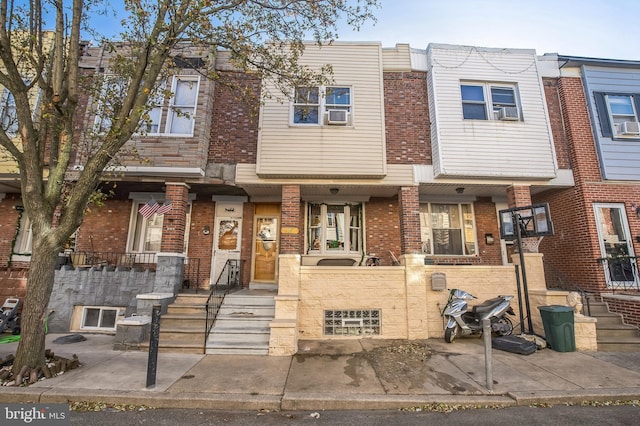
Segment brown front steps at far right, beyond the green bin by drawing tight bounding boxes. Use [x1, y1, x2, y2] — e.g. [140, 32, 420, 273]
[585, 301, 640, 352]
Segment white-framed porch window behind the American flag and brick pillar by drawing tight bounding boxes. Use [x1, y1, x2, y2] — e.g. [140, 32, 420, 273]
[127, 200, 191, 253]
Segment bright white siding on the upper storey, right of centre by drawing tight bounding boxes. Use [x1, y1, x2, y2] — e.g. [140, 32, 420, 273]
[427, 45, 556, 179]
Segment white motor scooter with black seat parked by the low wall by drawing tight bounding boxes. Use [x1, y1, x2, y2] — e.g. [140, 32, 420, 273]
[442, 288, 515, 343]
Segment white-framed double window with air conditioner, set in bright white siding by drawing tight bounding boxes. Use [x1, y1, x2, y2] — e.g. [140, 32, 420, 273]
[460, 83, 521, 121]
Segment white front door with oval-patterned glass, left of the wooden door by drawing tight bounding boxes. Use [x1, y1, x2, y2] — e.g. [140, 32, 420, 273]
[211, 202, 242, 284]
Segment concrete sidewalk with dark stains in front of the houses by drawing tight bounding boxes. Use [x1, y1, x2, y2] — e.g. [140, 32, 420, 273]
[0, 334, 640, 410]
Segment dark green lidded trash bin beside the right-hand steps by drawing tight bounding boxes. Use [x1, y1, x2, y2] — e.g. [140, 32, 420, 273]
[538, 305, 576, 352]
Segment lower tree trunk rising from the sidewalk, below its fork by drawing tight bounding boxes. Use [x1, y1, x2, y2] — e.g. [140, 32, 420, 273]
[13, 247, 58, 374]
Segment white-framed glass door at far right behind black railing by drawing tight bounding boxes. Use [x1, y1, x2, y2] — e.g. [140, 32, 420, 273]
[594, 203, 638, 288]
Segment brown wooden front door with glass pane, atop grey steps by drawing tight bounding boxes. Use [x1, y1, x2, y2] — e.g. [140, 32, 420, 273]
[252, 204, 280, 283]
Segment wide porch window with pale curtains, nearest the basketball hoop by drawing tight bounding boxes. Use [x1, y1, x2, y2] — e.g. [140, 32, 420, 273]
[420, 203, 477, 256]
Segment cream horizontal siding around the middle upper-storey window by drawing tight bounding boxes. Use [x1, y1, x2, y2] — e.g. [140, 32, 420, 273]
[256, 43, 386, 178]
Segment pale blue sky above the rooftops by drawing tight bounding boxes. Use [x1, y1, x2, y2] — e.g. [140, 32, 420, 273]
[80, 0, 640, 61]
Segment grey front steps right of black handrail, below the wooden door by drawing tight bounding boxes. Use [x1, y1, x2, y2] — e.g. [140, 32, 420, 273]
[205, 289, 276, 355]
